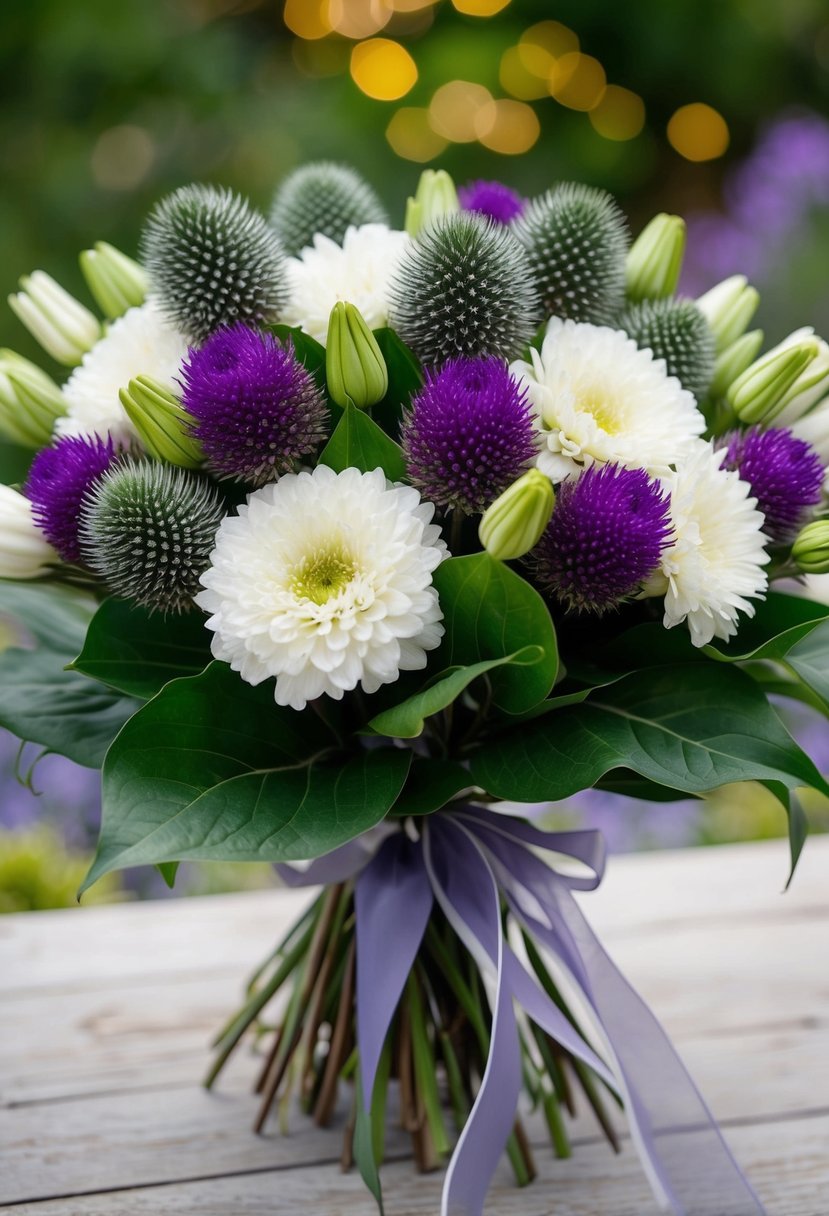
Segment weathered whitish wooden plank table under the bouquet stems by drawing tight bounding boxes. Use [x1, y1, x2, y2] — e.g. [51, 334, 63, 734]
[0, 841, 829, 1216]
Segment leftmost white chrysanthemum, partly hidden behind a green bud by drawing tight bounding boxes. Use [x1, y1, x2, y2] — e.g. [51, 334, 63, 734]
[56, 300, 187, 443]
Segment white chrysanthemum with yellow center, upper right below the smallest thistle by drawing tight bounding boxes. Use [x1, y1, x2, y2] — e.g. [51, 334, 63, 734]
[511, 317, 705, 482]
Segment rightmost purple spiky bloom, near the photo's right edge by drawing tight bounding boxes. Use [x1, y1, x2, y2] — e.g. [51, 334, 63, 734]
[720, 427, 823, 544]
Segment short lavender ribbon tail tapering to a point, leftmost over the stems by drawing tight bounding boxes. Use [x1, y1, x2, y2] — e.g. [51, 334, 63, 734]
[354, 832, 433, 1110]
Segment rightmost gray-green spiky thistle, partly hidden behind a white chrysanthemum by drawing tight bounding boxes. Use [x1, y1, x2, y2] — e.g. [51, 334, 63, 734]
[617, 299, 715, 401]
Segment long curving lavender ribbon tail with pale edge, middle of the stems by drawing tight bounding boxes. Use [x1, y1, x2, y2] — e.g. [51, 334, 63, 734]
[424, 817, 521, 1216]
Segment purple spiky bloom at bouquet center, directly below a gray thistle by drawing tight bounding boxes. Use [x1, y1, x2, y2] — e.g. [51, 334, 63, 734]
[401, 355, 536, 514]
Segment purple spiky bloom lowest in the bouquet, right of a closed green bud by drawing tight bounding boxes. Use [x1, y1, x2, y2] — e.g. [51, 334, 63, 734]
[532, 465, 671, 612]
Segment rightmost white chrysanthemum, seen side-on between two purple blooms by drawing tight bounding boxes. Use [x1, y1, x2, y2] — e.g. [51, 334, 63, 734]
[647, 443, 768, 646]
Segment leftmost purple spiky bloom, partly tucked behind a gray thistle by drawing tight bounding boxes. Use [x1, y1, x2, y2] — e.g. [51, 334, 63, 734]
[24, 435, 118, 562]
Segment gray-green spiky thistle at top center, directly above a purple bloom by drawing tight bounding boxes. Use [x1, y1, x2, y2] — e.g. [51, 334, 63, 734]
[390, 212, 541, 365]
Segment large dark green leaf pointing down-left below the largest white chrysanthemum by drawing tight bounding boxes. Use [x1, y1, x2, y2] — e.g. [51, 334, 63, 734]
[84, 663, 411, 888]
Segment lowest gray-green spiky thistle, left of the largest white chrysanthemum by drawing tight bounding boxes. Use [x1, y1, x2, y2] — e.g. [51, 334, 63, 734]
[79, 460, 225, 613]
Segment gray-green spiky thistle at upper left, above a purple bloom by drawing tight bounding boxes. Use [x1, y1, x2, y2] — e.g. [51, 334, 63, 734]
[141, 185, 288, 342]
